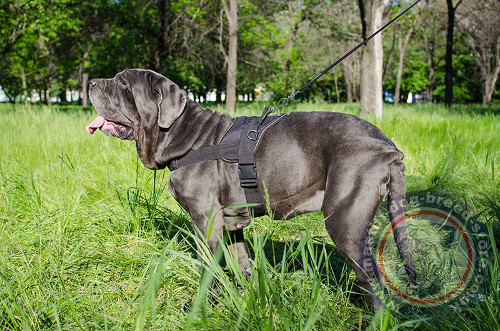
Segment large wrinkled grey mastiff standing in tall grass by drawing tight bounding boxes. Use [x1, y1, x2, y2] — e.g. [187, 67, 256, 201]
[87, 69, 416, 306]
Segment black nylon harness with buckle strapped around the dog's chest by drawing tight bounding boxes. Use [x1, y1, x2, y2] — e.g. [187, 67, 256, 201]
[167, 115, 285, 217]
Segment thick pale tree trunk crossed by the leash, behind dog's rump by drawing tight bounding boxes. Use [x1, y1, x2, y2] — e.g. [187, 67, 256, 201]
[358, 0, 389, 118]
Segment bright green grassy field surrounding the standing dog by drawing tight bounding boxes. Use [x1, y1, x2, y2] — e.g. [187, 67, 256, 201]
[0, 103, 500, 330]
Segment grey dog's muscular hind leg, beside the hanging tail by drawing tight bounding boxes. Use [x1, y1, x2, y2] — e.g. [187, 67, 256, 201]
[322, 175, 382, 307]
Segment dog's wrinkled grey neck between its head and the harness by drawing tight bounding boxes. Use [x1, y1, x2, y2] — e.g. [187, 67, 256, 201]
[155, 99, 233, 168]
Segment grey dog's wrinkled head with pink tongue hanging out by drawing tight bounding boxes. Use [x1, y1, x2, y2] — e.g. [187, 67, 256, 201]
[86, 69, 187, 169]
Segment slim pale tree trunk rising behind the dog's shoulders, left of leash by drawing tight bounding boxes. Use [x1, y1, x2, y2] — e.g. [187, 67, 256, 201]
[222, 0, 238, 115]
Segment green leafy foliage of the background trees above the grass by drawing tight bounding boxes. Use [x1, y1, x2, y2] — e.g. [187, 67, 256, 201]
[0, 0, 498, 103]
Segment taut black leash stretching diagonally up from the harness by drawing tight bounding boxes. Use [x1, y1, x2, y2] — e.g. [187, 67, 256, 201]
[259, 0, 422, 124]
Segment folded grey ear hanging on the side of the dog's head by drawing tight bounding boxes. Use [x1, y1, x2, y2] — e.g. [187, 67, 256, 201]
[153, 77, 187, 129]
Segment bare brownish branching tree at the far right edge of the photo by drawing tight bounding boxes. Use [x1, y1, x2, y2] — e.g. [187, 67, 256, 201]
[458, 0, 500, 105]
